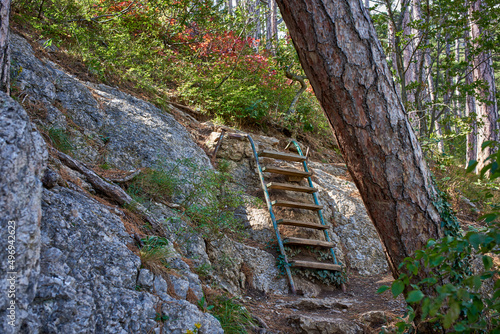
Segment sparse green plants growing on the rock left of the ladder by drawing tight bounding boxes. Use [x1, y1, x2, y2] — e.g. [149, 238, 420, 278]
[127, 159, 245, 240]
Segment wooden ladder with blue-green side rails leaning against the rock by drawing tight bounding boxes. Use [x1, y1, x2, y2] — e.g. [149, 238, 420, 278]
[246, 135, 342, 294]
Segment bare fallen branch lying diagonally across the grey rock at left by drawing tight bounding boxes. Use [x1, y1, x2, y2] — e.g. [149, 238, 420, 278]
[50, 148, 165, 232]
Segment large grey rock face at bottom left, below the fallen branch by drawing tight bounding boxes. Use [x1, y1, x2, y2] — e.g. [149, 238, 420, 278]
[21, 187, 223, 334]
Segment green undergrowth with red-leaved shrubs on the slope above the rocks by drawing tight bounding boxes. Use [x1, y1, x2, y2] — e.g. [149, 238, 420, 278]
[12, 0, 331, 137]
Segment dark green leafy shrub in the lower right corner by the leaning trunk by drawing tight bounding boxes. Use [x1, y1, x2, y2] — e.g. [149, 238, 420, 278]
[379, 143, 500, 333]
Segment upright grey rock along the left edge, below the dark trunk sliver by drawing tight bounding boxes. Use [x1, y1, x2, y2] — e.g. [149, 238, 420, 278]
[0, 92, 47, 333]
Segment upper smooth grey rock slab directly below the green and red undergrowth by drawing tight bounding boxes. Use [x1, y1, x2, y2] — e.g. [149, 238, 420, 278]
[11, 34, 210, 170]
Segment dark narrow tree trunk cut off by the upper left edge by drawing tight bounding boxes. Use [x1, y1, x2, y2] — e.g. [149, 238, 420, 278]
[0, 0, 10, 95]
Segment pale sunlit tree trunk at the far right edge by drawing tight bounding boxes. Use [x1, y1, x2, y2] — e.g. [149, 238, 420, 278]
[469, 0, 498, 171]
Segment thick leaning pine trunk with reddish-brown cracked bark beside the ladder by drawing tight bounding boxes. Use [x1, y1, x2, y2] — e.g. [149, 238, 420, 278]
[277, 0, 443, 277]
